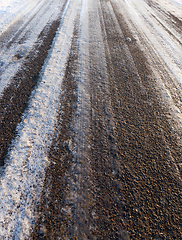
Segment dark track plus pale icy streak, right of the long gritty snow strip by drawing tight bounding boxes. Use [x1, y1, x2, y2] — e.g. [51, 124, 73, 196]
[32, 1, 95, 239]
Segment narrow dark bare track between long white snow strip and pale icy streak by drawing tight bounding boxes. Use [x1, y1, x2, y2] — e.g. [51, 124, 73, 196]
[32, 21, 78, 239]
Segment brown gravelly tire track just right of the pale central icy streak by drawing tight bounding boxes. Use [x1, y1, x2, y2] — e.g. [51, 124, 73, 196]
[89, 1, 129, 239]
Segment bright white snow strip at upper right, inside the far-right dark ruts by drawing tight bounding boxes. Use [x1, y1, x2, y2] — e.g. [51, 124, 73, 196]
[120, 0, 182, 86]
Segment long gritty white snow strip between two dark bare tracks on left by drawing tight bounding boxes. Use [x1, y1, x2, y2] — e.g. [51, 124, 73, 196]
[0, 0, 79, 239]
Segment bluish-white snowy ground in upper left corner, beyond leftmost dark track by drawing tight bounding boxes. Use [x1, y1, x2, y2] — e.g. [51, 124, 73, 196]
[0, 0, 65, 95]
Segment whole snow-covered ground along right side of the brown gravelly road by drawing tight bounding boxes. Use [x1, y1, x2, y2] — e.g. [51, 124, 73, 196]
[113, 0, 182, 138]
